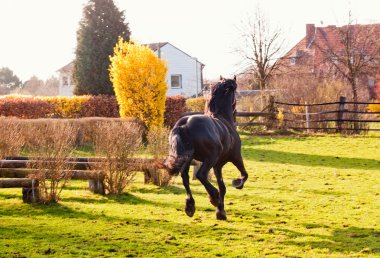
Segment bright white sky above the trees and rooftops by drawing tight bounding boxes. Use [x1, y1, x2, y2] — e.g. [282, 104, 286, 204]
[0, 0, 380, 81]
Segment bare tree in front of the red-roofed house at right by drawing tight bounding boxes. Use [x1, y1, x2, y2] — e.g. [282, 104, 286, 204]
[317, 12, 380, 129]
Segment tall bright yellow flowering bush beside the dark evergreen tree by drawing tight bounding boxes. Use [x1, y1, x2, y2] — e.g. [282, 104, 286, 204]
[110, 38, 168, 130]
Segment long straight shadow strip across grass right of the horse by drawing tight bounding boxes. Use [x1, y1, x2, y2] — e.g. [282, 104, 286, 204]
[243, 147, 380, 171]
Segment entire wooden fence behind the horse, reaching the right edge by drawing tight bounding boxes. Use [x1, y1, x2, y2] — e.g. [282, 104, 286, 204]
[182, 97, 380, 133]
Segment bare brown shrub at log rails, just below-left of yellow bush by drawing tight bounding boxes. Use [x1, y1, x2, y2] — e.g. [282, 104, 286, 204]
[94, 120, 141, 194]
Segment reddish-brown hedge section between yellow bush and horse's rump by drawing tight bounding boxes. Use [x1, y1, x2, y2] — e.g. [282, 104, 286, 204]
[164, 96, 187, 128]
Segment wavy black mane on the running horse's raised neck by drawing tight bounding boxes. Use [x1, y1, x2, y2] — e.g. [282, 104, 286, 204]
[205, 80, 236, 119]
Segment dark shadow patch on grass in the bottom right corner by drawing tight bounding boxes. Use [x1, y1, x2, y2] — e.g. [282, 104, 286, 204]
[278, 224, 380, 254]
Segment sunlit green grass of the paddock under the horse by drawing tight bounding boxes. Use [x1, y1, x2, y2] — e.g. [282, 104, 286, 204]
[0, 135, 380, 257]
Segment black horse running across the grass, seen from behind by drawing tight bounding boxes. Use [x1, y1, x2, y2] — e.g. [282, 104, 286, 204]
[164, 77, 248, 220]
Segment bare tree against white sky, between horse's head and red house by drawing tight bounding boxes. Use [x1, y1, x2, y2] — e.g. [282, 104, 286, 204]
[237, 7, 284, 95]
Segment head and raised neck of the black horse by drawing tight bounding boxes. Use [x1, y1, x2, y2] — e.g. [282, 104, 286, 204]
[207, 76, 237, 120]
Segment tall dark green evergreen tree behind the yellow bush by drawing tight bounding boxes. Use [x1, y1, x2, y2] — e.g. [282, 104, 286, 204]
[73, 0, 130, 95]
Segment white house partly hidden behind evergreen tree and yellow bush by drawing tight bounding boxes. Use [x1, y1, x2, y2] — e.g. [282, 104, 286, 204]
[57, 42, 205, 97]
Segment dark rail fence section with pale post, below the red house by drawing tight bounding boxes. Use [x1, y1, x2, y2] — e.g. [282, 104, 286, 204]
[275, 97, 380, 133]
